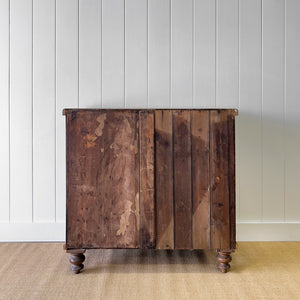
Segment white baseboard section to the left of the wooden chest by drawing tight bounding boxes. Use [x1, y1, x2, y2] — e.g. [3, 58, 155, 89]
[0, 222, 66, 242]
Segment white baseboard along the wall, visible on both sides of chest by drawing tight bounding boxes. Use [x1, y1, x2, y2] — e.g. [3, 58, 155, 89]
[0, 222, 300, 242]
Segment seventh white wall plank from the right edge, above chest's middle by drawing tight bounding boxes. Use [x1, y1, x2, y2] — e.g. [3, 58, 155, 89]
[148, 0, 170, 108]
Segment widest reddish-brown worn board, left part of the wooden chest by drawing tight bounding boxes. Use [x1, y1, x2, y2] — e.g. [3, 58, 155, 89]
[67, 110, 140, 248]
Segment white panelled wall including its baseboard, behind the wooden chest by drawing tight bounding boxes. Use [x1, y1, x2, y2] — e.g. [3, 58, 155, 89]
[0, 0, 300, 241]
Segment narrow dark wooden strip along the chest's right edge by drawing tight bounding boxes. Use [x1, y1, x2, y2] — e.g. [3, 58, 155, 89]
[228, 112, 236, 249]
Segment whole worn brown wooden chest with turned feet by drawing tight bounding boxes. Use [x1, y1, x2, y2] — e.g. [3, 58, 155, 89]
[63, 109, 237, 273]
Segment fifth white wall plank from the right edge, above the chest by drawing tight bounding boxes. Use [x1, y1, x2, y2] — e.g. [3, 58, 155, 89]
[193, 0, 216, 107]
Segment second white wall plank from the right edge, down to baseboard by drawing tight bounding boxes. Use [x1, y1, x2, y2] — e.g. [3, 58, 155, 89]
[262, 0, 284, 222]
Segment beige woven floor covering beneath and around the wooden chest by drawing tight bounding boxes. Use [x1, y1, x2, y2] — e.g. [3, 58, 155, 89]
[0, 242, 300, 300]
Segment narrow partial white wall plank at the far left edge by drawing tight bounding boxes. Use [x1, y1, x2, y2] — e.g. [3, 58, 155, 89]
[0, 0, 10, 222]
